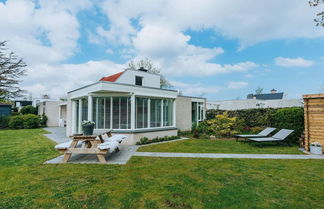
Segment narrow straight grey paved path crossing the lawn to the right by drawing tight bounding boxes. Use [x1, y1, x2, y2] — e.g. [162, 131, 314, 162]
[134, 152, 324, 159]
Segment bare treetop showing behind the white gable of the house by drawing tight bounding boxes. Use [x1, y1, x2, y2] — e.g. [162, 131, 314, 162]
[127, 58, 172, 88]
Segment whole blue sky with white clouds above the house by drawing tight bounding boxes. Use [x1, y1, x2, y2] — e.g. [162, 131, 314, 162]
[0, 0, 324, 100]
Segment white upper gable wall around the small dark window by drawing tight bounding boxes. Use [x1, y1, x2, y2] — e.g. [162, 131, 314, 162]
[116, 70, 160, 88]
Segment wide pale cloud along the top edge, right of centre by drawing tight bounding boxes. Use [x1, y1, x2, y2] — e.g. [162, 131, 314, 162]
[101, 0, 324, 47]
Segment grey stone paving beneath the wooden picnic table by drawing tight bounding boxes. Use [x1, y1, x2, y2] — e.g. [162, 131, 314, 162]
[44, 145, 138, 164]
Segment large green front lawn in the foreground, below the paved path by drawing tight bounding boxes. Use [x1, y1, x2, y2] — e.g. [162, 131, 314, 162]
[0, 130, 324, 209]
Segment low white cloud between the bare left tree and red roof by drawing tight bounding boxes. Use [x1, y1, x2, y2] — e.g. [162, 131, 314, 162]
[22, 61, 124, 98]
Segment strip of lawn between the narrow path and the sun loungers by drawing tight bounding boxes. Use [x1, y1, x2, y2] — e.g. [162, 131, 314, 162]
[138, 139, 304, 154]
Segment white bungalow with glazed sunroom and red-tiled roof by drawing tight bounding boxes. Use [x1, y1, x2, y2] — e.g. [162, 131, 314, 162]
[66, 69, 206, 145]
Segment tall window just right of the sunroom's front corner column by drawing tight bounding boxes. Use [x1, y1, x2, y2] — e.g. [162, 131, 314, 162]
[135, 97, 148, 128]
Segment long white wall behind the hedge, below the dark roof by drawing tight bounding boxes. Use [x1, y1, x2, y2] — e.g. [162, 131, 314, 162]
[207, 99, 304, 110]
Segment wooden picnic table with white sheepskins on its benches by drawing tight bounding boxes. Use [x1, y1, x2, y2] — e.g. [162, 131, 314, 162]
[55, 131, 127, 163]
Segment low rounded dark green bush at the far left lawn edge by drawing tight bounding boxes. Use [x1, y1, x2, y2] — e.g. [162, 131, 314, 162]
[9, 114, 40, 129]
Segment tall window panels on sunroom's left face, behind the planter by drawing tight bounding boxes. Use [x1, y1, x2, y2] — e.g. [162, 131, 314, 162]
[93, 97, 131, 129]
